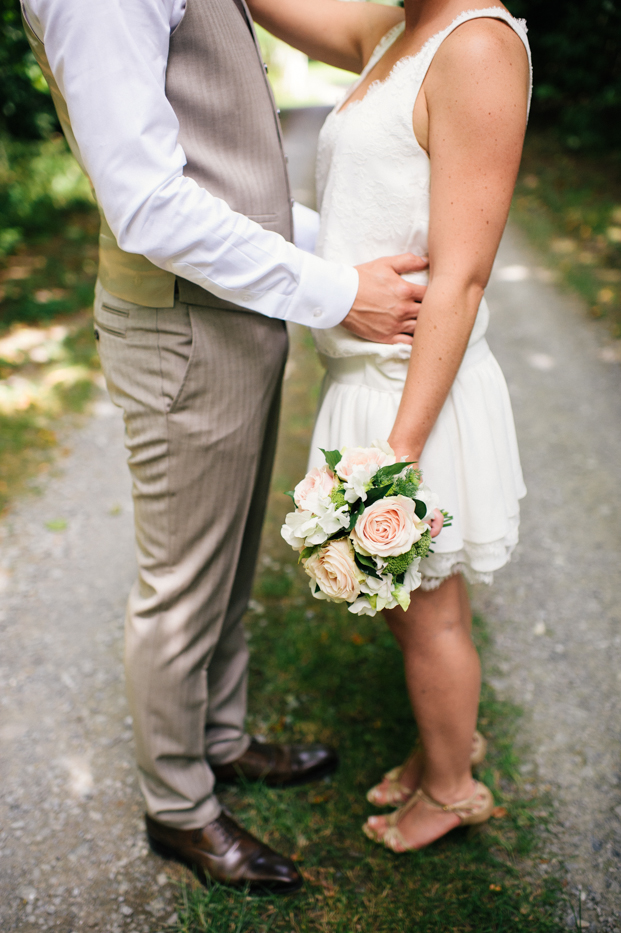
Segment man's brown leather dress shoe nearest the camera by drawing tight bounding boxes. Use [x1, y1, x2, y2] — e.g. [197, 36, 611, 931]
[145, 811, 302, 894]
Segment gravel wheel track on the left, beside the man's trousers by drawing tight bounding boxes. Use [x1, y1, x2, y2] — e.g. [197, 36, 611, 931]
[0, 399, 184, 933]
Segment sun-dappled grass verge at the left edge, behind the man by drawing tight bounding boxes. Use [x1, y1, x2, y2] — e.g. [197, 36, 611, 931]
[0, 138, 99, 513]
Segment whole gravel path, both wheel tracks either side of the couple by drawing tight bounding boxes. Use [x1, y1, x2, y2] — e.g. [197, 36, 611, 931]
[0, 108, 621, 933]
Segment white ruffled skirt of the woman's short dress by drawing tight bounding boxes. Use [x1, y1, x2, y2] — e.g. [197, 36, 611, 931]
[309, 332, 526, 590]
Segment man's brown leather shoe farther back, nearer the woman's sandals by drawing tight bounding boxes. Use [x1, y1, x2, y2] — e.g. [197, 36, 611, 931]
[211, 739, 339, 787]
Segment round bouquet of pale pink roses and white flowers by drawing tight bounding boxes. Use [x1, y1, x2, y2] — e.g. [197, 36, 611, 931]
[281, 441, 448, 616]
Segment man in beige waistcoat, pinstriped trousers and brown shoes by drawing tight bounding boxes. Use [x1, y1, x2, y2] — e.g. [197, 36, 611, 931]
[22, 0, 423, 892]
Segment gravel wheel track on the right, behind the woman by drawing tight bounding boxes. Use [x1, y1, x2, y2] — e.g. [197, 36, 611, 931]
[475, 229, 621, 930]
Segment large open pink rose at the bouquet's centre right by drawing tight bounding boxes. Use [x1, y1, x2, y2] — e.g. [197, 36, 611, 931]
[351, 496, 427, 557]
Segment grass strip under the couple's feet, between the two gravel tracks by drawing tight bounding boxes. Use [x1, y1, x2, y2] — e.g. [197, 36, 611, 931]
[167, 326, 563, 933]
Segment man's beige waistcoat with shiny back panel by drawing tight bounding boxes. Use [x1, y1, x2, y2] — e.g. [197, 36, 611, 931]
[24, 0, 293, 308]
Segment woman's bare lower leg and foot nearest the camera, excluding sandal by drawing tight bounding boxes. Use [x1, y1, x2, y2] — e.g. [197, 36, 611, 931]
[369, 576, 480, 847]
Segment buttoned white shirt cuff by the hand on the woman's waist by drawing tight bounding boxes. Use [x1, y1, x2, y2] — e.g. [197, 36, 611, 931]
[285, 253, 359, 330]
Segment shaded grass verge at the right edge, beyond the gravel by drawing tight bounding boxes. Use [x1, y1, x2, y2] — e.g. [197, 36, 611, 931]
[512, 131, 621, 338]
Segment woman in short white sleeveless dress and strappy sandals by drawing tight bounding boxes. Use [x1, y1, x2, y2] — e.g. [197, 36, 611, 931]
[249, 0, 531, 852]
